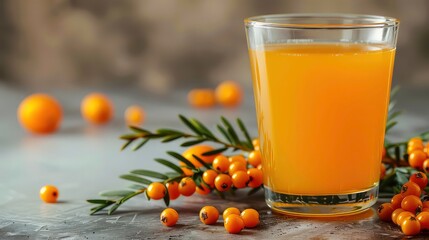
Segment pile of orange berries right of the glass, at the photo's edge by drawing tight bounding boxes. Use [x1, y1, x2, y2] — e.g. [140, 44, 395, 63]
[377, 172, 429, 236]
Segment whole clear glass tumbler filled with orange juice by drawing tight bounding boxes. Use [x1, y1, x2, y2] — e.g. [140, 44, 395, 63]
[245, 14, 399, 216]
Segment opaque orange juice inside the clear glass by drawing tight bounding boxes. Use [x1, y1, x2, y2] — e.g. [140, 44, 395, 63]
[250, 43, 395, 196]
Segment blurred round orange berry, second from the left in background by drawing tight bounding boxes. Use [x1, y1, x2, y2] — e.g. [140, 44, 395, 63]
[80, 93, 114, 124]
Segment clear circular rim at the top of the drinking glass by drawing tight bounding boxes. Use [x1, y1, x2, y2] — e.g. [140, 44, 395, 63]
[244, 13, 399, 29]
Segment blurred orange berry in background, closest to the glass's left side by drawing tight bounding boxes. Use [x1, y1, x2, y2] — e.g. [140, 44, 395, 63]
[215, 81, 243, 107]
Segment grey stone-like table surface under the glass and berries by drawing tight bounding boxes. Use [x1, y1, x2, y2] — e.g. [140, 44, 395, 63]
[0, 84, 429, 239]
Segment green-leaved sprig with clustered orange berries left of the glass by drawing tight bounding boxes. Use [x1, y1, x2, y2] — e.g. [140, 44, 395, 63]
[87, 115, 263, 214]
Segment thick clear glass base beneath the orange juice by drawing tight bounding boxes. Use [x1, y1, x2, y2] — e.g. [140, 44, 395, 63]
[265, 184, 378, 217]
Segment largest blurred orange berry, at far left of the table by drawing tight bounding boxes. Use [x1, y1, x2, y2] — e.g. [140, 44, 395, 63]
[17, 94, 63, 134]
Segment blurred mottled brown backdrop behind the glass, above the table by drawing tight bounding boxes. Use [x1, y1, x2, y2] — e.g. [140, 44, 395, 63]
[0, 0, 429, 94]
